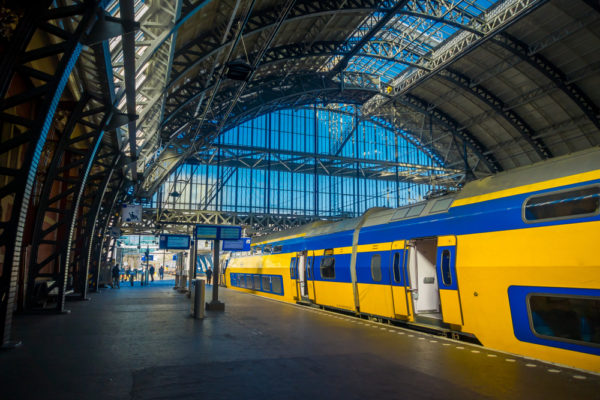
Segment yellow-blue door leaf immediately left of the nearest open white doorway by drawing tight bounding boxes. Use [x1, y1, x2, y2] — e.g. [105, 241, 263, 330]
[390, 240, 410, 319]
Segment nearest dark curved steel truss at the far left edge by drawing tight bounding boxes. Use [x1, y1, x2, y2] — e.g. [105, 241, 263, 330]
[0, 1, 98, 344]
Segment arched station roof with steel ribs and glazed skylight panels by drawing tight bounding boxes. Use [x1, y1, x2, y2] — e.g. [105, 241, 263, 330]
[91, 0, 600, 193]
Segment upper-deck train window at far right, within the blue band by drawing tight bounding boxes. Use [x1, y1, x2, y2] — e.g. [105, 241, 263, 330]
[523, 186, 600, 222]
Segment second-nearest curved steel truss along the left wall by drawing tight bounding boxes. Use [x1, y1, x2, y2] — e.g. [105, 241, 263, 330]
[26, 93, 112, 312]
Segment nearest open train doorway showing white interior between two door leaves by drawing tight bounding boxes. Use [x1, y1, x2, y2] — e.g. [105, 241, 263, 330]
[407, 238, 442, 322]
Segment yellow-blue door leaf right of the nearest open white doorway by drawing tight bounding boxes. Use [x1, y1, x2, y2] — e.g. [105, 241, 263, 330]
[437, 236, 464, 325]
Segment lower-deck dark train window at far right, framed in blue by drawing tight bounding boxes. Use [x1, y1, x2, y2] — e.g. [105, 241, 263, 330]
[528, 294, 600, 347]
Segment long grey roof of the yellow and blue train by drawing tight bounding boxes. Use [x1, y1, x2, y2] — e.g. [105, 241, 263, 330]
[253, 147, 600, 244]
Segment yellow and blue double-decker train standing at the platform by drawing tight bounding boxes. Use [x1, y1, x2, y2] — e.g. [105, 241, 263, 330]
[226, 148, 600, 372]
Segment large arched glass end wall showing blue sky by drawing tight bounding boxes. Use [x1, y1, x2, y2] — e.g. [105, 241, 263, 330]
[146, 106, 454, 216]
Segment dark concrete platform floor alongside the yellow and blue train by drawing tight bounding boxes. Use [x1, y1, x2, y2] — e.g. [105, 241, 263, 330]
[0, 281, 600, 400]
